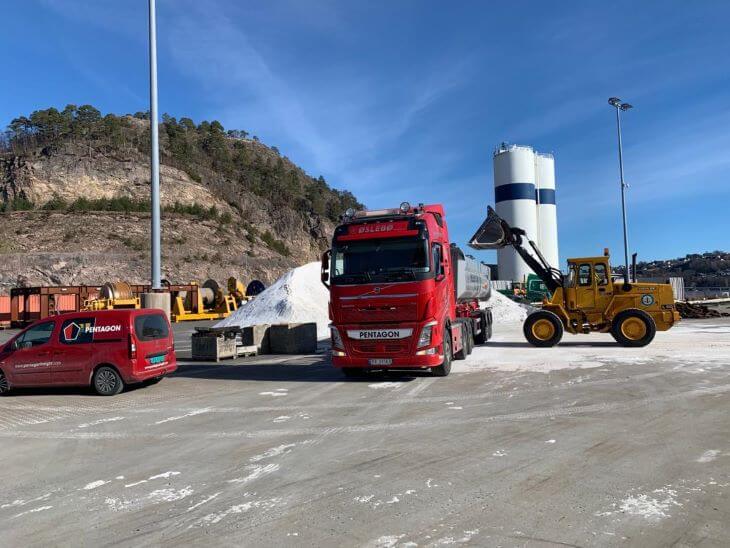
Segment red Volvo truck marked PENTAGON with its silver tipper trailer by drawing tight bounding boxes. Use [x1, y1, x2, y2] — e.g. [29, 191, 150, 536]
[322, 202, 492, 376]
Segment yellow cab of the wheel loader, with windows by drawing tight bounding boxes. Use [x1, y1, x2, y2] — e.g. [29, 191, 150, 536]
[565, 256, 614, 313]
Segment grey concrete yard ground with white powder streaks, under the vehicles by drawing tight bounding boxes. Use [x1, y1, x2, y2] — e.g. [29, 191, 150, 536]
[0, 320, 730, 547]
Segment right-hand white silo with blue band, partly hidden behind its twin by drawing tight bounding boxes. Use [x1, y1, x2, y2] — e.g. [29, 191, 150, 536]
[535, 153, 560, 269]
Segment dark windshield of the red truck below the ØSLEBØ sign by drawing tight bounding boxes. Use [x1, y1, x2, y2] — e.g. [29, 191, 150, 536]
[331, 238, 432, 285]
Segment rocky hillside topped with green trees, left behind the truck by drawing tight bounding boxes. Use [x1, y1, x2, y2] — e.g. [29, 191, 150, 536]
[0, 105, 360, 291]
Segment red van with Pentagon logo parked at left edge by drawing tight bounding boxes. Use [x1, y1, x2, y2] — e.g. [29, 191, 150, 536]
[0, 309, 177, 396]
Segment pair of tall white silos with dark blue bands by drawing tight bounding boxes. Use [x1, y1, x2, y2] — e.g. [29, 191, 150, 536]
[494, 143, 560, 282]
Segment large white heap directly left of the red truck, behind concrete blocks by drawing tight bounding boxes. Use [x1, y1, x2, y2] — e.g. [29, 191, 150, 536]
[216, 262, 330, 339]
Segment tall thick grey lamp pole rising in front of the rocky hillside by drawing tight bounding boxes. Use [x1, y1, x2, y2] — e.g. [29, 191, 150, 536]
[149, 0, 162, 290]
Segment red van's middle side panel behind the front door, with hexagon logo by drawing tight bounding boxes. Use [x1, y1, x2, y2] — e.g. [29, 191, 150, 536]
[51, 318, 94, 385]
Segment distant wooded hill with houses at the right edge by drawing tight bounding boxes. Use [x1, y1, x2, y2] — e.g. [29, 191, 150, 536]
[636, 251, 730, 287]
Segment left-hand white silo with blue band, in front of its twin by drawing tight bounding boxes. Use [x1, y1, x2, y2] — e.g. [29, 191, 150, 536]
[494, 144, 538, 281]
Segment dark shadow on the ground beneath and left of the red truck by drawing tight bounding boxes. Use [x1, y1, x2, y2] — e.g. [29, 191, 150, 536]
[172, 358, 420, 383]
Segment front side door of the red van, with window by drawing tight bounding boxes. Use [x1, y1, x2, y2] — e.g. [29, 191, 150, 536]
[5, 320, 56, 386]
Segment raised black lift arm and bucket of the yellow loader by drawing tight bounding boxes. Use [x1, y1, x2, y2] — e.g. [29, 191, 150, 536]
[469, 206, 563, 293]
